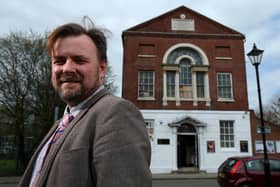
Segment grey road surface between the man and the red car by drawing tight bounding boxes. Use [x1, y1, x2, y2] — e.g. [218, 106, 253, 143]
[153, 179, 219, 187]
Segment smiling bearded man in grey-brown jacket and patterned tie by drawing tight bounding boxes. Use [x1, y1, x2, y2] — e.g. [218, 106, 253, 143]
[19, 24, 152, 187]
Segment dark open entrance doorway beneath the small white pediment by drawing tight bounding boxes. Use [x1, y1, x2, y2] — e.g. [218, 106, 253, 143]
[177, 135, 197, 168]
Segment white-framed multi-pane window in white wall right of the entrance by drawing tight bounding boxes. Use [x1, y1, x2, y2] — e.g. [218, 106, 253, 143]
[220, 120, 234, 148]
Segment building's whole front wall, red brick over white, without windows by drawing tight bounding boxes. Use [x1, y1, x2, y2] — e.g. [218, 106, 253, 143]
[122, 7, 252, 173]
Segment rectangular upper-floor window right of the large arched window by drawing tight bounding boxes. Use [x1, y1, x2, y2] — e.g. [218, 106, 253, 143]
[217, 73, 233, 99]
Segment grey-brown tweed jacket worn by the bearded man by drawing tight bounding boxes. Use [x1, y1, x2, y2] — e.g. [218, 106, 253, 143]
[19, 89, 152, 187]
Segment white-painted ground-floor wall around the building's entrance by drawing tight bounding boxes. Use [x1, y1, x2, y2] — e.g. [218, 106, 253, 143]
[141, 110, 252, 173]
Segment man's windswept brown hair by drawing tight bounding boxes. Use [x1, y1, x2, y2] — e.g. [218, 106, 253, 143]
[47, 23, 107, 62]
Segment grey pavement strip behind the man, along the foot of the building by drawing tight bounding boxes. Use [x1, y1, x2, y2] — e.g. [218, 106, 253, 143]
[0, 172, 217, 184]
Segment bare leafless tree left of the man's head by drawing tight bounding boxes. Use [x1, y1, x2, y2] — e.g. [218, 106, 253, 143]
[0, 32, 63, 171]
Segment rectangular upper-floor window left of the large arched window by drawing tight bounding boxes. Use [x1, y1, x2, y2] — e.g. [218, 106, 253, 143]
[138, 71, 154, 98]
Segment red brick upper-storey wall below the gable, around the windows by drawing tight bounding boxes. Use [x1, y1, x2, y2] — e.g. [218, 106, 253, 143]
[122, 35, 248, 110]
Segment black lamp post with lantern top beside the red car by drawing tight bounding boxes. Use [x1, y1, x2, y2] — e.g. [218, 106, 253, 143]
[247, 44, 272, 187]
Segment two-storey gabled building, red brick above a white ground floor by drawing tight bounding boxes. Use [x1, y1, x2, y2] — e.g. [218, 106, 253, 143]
[122, 6, 252, 173]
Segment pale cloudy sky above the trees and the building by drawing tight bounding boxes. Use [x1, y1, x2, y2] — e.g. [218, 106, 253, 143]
[0, 0, 280, 109]
